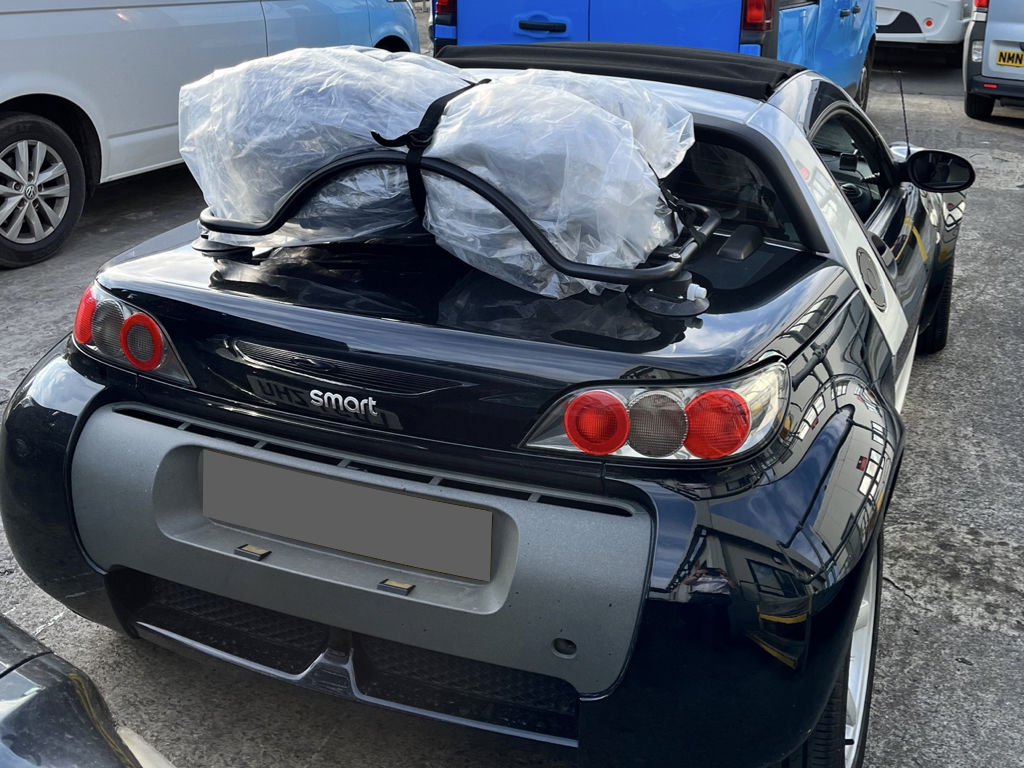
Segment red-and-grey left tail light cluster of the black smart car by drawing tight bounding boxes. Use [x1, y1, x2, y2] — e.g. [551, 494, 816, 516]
[73, 284, 193, 385]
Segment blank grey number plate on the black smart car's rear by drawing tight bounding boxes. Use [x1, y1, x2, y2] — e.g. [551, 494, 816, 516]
[203, 451, 492, 582]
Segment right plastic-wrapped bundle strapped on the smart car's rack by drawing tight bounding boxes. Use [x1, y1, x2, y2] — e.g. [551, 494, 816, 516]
[424, 72, 693, 298]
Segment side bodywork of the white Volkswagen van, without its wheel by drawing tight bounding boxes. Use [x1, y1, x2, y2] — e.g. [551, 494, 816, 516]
[0, 0, 419, 181]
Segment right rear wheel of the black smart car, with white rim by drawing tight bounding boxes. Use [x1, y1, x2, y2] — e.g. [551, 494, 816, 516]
[772, 536, 882, 768]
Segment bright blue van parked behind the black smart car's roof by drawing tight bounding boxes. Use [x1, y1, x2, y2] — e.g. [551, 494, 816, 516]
[431, 0, 874, 106]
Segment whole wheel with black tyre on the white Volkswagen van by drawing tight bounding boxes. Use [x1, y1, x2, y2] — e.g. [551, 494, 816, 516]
[0, 115, 86, 268]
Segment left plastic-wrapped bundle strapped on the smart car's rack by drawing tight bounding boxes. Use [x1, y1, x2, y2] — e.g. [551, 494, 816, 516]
[179, 46, 474, 239]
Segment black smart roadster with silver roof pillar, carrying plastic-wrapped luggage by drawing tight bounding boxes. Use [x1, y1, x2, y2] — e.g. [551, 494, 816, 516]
[0, 44, 974, 768]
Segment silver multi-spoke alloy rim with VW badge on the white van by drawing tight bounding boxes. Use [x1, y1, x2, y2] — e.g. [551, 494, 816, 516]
[0, 139, 71, 245]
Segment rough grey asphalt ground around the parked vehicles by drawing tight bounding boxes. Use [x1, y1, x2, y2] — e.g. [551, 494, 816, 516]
[0, 18, 1024, 768]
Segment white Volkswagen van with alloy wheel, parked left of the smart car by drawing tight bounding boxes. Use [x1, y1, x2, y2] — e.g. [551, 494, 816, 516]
[0, 0, 420, 267]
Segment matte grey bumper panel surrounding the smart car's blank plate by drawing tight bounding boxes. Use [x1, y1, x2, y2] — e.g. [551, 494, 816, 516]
[72, 407, 652, 695]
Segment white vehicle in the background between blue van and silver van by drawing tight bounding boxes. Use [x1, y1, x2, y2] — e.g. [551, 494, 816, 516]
[877, 0, 974, 60]
